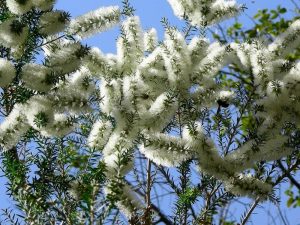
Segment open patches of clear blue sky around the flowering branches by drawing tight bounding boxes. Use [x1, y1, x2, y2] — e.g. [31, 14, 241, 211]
[0, 0, 300, 225]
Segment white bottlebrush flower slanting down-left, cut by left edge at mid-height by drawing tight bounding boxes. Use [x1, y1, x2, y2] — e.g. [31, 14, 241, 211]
[0, 104, 30, 151]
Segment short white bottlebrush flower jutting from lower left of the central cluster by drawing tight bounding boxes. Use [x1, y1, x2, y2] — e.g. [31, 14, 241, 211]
[87, 120, 113, 148]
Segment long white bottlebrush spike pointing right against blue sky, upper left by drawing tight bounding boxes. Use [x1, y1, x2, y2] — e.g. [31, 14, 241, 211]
[68, 6, 120, 38]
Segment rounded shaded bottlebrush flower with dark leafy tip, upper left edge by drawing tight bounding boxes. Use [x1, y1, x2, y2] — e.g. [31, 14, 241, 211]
[0, 18, 28, 48]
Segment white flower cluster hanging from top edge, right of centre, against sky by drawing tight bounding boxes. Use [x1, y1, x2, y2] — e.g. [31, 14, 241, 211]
[168, 0, 240, 26]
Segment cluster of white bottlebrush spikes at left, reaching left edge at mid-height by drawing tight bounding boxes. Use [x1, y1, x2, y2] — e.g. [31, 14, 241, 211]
[0, 66, 95, 150]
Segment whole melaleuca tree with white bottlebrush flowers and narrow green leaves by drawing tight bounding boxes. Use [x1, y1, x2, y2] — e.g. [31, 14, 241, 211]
[0, 0, 300, 224]
